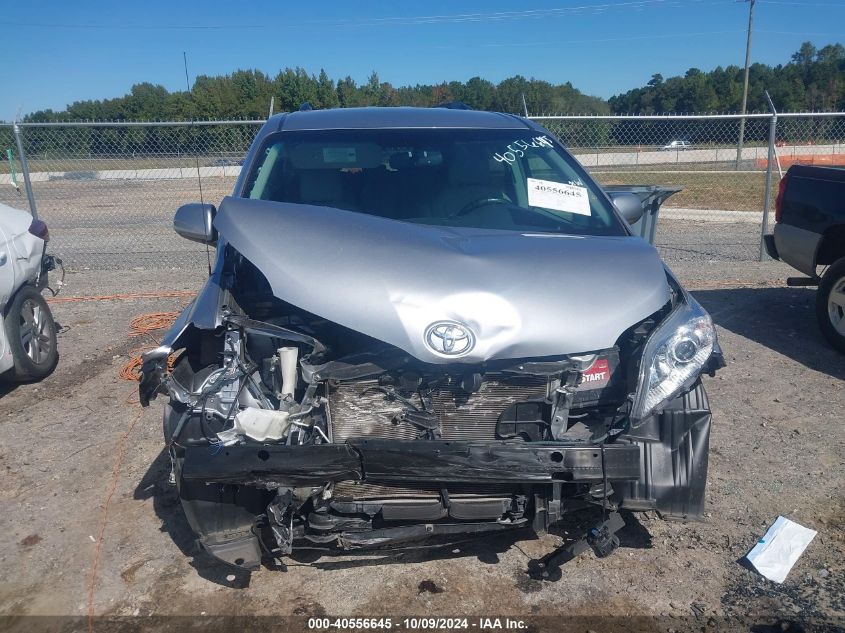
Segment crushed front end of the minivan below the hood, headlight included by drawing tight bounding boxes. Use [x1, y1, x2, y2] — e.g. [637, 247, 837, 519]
[140, 238, 721, 569]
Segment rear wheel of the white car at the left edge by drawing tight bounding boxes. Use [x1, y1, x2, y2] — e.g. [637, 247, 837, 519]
[3, 286, 59, 382]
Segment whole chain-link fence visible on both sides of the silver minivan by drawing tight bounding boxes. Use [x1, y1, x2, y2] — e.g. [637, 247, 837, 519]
[0, 113, 845, 270]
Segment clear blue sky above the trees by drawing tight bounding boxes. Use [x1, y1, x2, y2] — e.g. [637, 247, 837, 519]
[0, 0, 845, 120]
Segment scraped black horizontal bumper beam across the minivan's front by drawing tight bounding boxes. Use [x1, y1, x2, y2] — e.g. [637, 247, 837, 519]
[182, 438, 640, 488]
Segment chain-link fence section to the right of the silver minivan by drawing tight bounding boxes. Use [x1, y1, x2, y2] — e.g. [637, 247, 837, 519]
[536, 113, 845, 261]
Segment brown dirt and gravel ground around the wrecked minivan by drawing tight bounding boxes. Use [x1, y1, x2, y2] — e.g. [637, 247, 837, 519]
[0, 257, 845, 631]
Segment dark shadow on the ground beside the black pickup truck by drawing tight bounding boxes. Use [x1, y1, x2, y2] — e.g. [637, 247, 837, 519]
[692, 286, 845, 379]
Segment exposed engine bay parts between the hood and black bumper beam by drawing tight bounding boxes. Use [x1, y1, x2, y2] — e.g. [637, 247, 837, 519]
[165, 308, 636, 456]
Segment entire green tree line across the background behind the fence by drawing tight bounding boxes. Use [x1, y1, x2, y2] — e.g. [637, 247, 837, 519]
[21, 42, 845, 121]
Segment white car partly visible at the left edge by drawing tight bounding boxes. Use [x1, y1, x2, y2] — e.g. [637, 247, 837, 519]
[0, 204, 59, 382]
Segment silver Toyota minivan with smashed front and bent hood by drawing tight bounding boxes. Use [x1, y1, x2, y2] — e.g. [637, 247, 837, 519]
[140, 108, 722, 569]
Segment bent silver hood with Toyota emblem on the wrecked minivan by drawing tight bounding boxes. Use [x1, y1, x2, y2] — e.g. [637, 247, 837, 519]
[214, 197, 669, 363]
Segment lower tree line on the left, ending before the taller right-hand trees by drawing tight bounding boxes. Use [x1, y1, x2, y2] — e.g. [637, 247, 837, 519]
[26, 68, 610, 121]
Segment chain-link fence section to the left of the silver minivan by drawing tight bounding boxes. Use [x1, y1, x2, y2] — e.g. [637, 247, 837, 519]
[0, 121, 264, 270]
